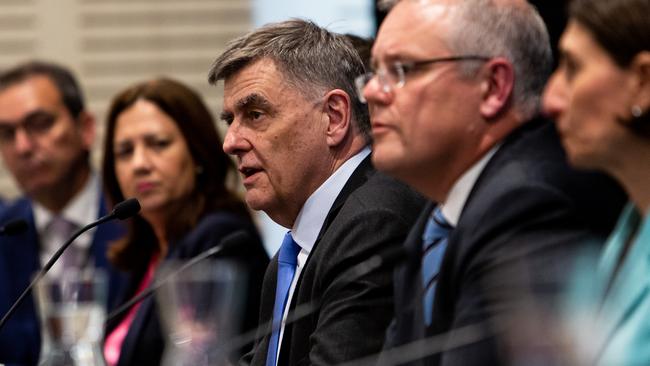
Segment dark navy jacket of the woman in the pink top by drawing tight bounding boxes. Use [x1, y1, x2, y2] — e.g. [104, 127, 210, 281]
[106, 212, 269, 366]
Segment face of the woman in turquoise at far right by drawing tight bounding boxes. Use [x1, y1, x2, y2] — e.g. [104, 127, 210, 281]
[544, 21, 635, 172]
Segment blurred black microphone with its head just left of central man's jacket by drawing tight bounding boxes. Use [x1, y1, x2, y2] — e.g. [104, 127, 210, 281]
[106, 230, 253, 322]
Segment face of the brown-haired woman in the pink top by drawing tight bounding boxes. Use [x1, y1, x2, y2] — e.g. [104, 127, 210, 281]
[113, 99, 196, 222]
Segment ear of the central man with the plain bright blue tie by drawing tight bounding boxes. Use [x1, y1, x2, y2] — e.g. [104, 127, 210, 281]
[324, 89, 352, 147]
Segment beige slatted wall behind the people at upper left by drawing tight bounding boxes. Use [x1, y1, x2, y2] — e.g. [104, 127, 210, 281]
[0, 0, 252, 197]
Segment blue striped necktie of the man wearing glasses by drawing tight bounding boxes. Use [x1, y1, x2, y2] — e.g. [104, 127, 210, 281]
[422, 207, 452, 326]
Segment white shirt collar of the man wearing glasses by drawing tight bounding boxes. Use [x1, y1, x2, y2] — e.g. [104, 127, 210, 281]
[440, 145, 501, 226]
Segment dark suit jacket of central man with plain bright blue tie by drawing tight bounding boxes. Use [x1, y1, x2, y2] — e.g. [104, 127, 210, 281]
[242, 157, 424, 366]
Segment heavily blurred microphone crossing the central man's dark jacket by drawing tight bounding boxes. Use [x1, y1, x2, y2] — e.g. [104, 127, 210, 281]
[214, 246, 408, 354]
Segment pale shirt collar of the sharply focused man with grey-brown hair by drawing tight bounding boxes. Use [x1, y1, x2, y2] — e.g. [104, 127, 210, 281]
[291, 146, 370, 253]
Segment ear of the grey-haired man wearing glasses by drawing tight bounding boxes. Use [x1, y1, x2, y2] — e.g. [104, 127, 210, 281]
[480, 57, 515, 120]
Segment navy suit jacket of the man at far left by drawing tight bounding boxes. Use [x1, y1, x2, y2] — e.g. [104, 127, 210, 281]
[0, 198, 124, 365]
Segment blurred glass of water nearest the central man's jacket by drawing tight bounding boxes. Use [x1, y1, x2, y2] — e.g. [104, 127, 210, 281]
[156, 260, 246, 366]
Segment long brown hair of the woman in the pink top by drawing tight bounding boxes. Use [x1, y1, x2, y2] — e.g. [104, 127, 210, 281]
[103, 78, 249, 270]
